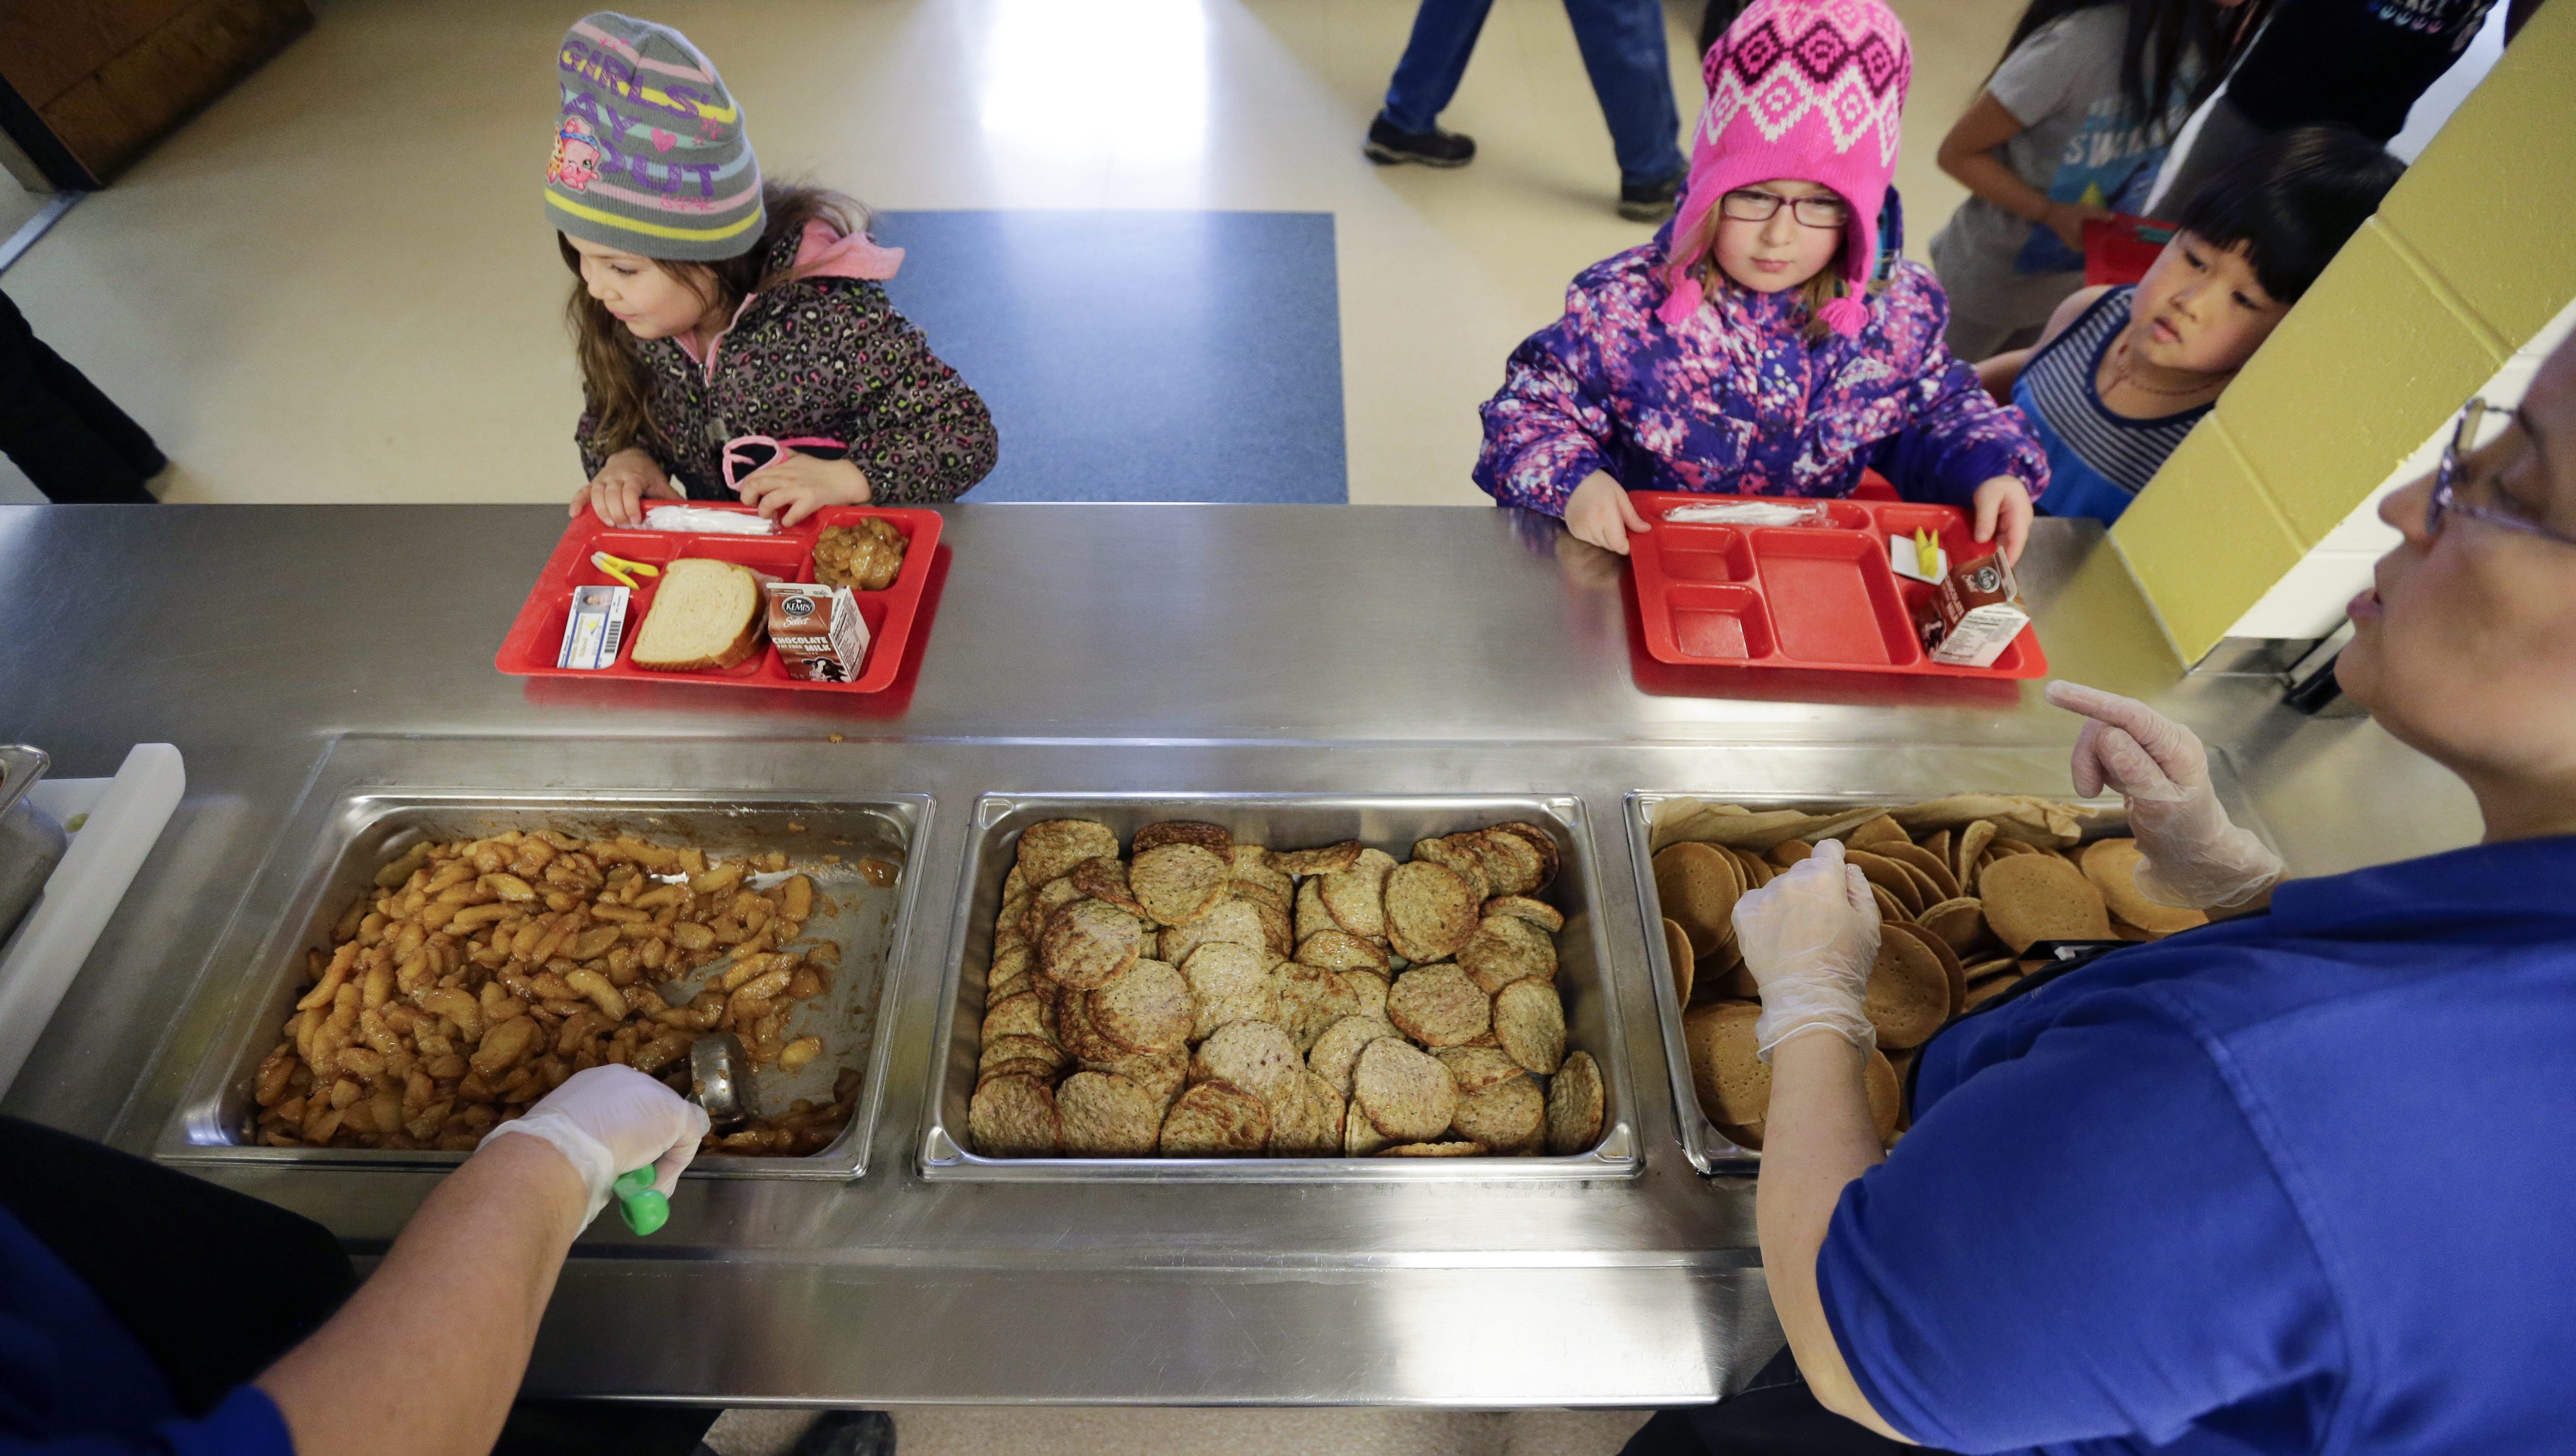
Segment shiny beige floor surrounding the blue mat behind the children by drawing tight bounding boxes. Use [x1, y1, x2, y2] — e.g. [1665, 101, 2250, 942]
[0, 0, 2020, 505]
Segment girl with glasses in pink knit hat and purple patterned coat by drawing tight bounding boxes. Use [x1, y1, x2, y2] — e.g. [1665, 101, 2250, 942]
[1476, 0, 2048, 556]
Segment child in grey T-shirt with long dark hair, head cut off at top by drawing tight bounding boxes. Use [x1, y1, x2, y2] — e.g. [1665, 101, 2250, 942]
[1932, 0, 2269, 358]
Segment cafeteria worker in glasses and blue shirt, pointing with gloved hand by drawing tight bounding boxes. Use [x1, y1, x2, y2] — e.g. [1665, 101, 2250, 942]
[1631, 323, 2576, 1456]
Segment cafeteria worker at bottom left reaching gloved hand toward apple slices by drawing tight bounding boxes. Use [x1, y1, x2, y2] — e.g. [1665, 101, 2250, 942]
[0, 1067, 714, 1456]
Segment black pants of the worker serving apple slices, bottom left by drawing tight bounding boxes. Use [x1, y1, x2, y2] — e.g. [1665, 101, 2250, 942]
[0, 1118, 719, 1456]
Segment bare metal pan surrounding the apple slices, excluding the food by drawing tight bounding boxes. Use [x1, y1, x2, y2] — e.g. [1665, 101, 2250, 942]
[155, 789, 930, 1178]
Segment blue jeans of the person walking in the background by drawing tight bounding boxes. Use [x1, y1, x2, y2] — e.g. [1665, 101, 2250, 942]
[1386, 0, 1690, 183]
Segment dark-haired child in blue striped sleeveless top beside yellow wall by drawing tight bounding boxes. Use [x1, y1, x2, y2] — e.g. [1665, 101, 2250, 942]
[1978, 126, 2406, 520]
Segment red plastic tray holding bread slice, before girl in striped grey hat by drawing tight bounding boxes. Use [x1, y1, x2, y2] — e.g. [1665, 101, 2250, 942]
[492, 500, 940, 693]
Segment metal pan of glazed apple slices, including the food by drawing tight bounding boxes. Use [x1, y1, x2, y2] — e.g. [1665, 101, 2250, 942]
[160, 789, 930, 1178]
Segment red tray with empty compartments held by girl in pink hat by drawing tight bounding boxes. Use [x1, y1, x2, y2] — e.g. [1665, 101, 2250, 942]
[1628, 490, 2048, 678]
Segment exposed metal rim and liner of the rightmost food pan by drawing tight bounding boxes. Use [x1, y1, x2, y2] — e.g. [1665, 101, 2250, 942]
[1626, 745, 2272, 1175]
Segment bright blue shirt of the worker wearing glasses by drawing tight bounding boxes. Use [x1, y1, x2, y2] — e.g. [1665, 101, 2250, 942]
[1816, 838, 2576, 1456]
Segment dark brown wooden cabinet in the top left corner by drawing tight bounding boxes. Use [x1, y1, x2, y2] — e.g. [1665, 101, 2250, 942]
[0, 0, 314, 188]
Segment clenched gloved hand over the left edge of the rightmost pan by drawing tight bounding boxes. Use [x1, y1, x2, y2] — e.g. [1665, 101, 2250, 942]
[1734, 840, 1878, 1062]
